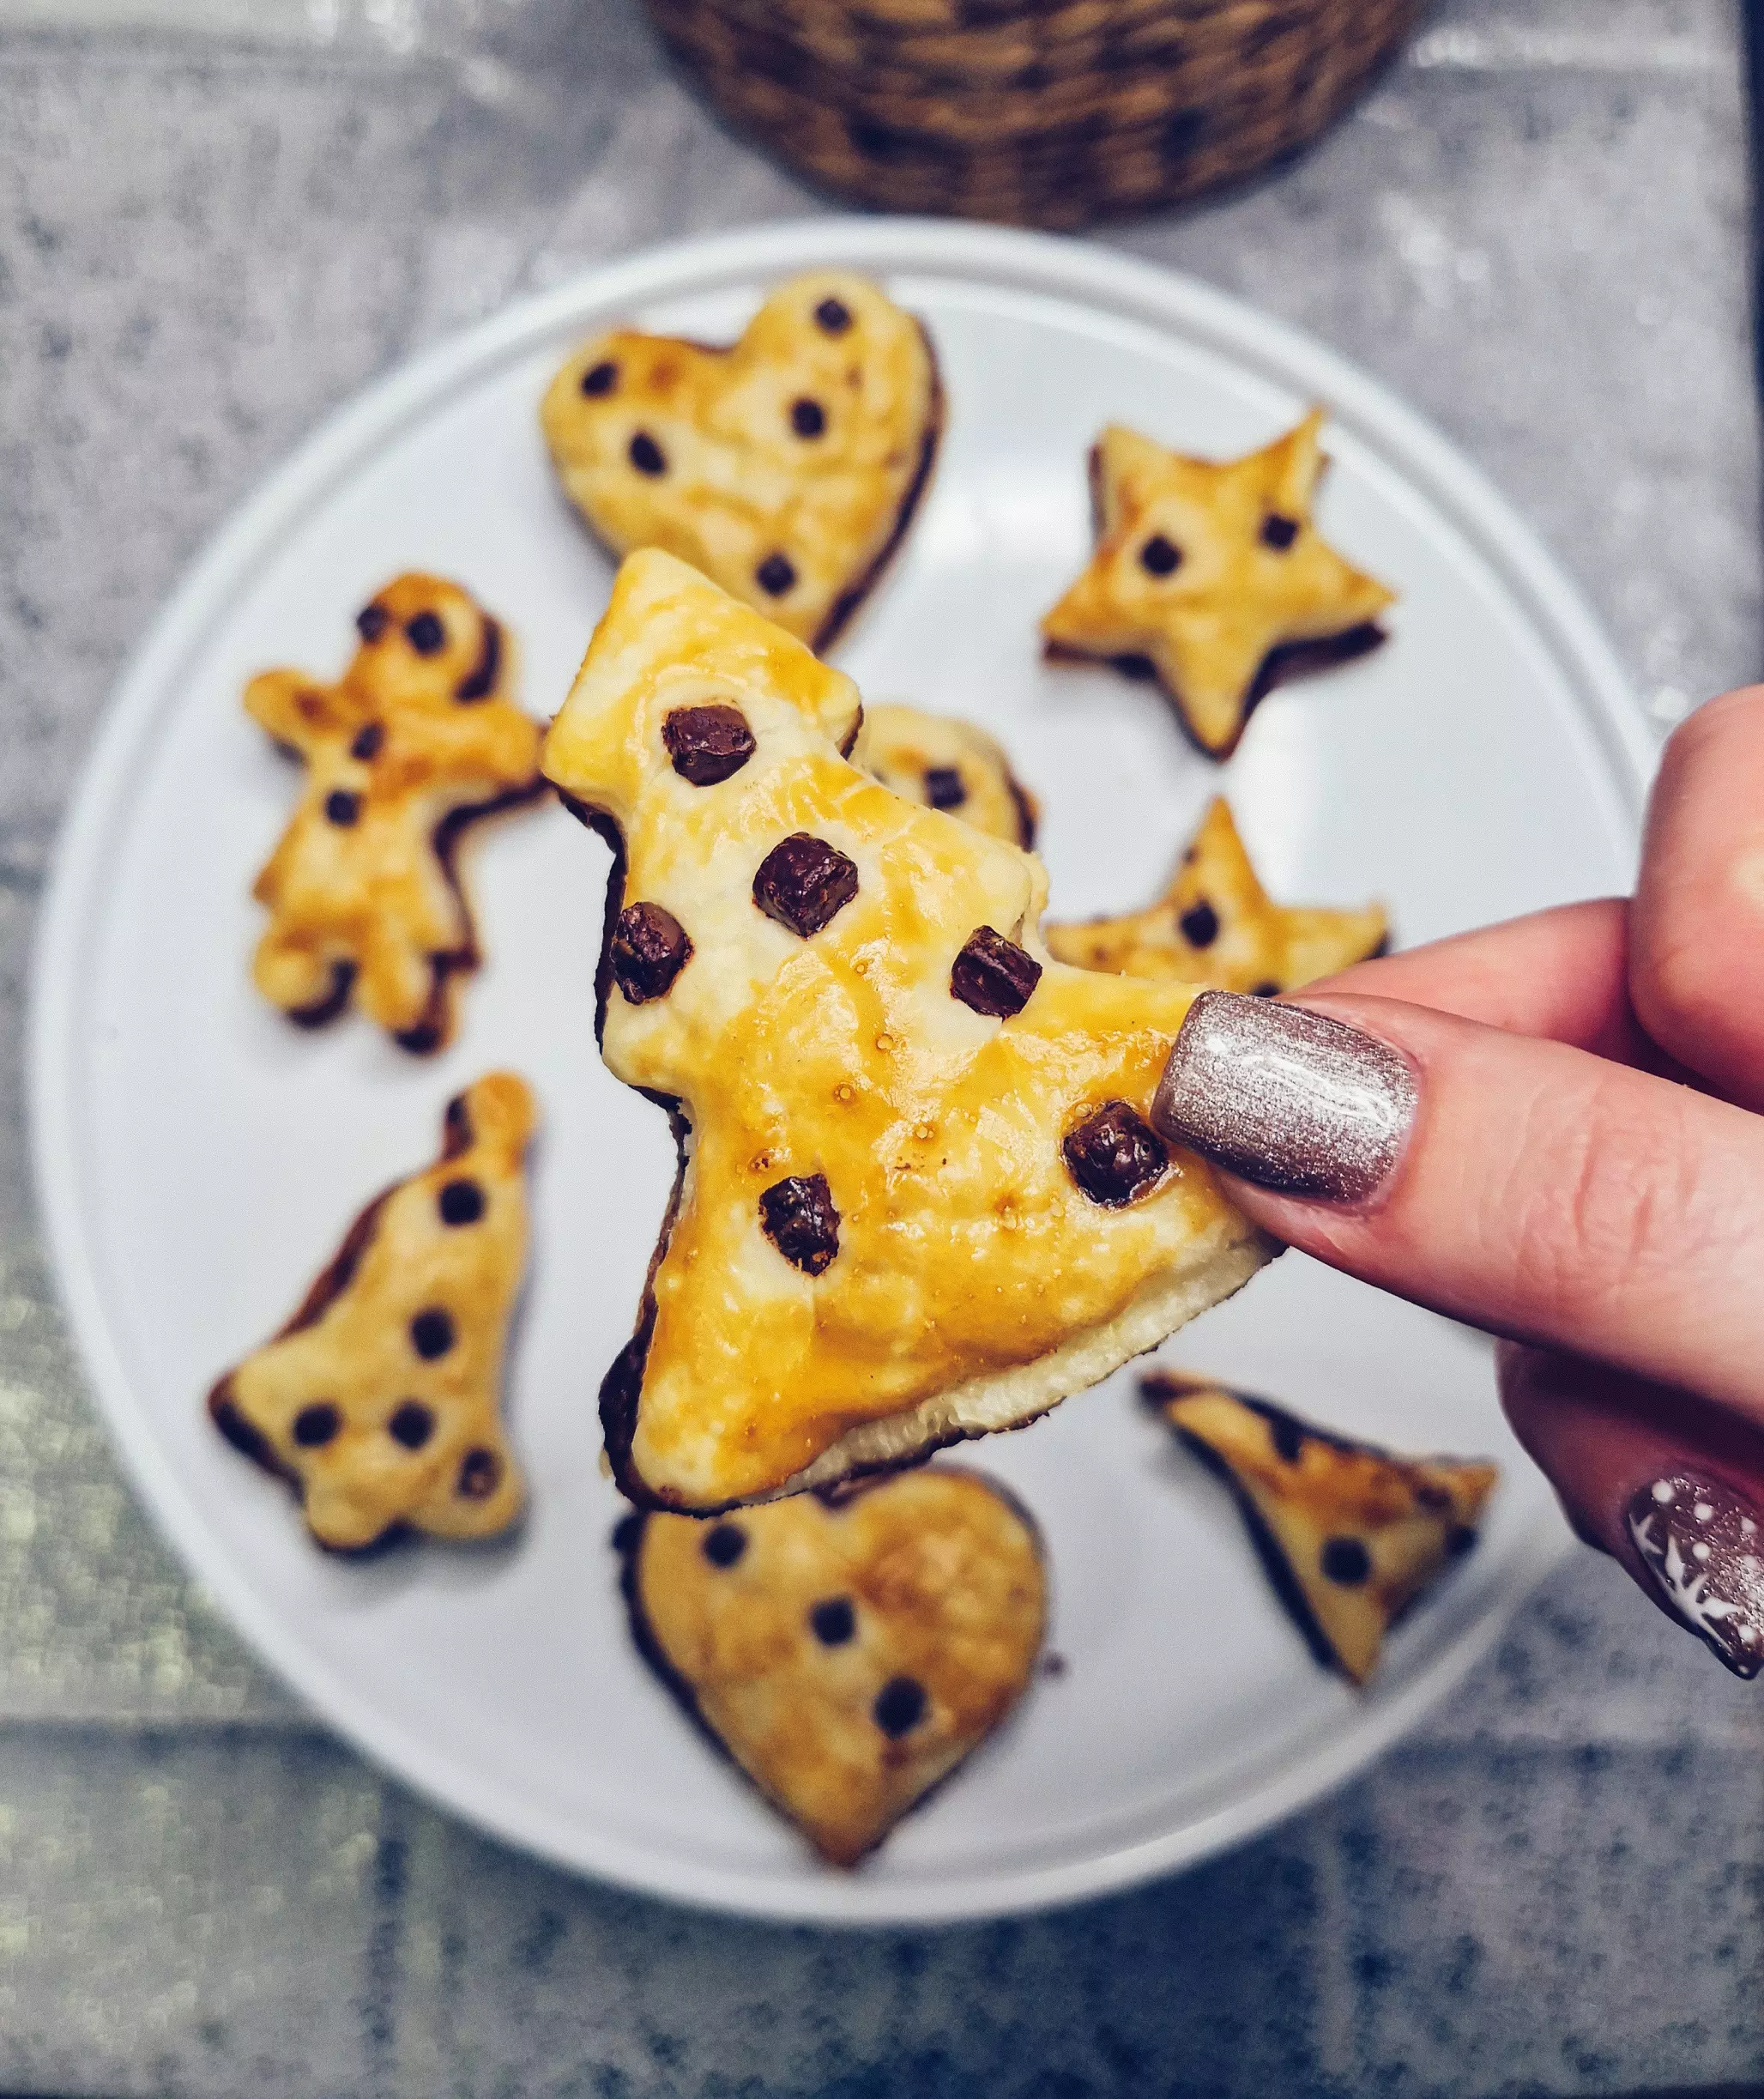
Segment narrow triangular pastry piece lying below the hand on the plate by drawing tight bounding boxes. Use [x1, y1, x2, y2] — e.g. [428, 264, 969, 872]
[1141, 1373, 1498, 1684]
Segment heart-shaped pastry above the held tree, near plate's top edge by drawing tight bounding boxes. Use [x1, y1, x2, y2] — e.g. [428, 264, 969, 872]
[541, 271, 942, 649]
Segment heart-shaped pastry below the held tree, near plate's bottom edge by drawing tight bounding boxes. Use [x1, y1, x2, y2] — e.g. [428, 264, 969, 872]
[619, 1465, 1047, 1866]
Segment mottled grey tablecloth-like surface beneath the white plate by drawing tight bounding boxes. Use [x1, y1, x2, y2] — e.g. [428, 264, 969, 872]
[0, 0, 1764, 2099]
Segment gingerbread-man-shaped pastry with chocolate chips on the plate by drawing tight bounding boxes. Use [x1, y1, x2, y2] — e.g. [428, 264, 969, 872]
[245, 575, 543, 1051]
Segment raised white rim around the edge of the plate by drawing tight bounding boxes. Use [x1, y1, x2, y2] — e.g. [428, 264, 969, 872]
[25, 216, 1657, 1927]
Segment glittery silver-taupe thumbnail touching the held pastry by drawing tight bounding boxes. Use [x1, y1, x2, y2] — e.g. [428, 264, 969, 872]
[1151, 991, 1416, 1203]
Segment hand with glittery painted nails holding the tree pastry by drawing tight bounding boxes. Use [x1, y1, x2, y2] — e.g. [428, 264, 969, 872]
[1154, 687, 1764, 1677]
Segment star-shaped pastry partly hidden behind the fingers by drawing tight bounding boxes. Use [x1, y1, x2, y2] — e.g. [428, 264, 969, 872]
[1047, 795, 1388, 999]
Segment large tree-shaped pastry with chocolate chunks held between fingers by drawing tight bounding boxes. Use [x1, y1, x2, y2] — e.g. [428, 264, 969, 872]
[543, 552, 1269, 1511]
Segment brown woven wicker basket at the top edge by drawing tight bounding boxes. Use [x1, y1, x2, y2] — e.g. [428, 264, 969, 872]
[648, 0, 1420, 227]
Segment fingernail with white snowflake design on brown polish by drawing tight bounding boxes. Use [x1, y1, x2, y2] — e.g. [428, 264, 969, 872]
[1630, 1472, 1764, 1677]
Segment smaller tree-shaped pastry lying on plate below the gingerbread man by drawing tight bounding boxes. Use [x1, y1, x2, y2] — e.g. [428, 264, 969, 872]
[208, 1070, 535, 1552]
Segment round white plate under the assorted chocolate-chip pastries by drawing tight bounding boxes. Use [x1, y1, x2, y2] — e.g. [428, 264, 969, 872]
[32, 221, 1649, 1921]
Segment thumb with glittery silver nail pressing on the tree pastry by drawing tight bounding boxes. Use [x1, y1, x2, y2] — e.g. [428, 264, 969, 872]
[1151, 991, 1764, 1421]
